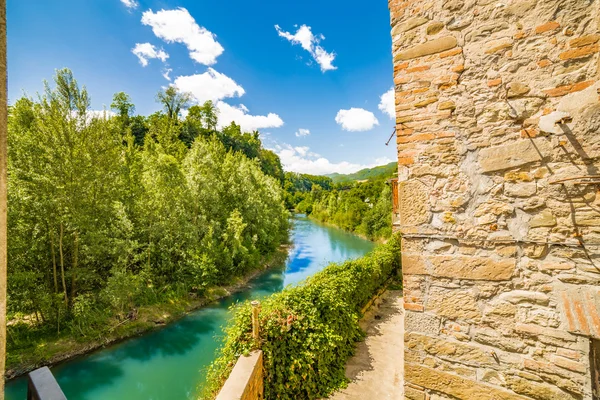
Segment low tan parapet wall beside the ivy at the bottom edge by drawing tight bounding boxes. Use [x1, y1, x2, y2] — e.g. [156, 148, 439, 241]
[216, 350, 264, 400]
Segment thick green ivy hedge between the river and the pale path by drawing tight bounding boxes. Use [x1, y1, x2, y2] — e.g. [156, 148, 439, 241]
[204, 237, 400, 399]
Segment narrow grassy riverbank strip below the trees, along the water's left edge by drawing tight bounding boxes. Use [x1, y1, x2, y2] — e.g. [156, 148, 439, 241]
[5, 245, 290, 380]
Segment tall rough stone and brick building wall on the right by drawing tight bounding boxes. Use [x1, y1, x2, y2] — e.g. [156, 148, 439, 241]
[389, 0, 600, 399]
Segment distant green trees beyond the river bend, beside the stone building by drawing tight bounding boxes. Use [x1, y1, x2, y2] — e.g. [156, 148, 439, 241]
[285, 173, 392, 240]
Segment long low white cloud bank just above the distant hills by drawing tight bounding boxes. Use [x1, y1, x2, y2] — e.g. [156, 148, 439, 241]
[273, 144, 392, 175]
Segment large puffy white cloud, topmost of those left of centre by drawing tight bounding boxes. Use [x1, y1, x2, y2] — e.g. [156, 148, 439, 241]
[142, 8, 223, 65]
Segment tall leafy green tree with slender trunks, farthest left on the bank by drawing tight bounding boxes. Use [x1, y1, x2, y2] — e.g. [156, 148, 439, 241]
[9, 69, 122, 324]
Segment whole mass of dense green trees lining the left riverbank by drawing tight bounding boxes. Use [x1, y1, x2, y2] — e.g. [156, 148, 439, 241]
[8, 69, 289, 360]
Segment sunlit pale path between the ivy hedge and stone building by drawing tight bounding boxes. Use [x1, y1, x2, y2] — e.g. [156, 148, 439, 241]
[330, 290, 404, 400]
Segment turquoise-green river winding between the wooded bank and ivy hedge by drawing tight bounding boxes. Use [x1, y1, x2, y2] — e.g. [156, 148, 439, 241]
[5, 216, 375, 400]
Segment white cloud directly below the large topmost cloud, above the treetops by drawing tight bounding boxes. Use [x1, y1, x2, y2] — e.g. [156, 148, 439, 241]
[174, 68, 245, 104]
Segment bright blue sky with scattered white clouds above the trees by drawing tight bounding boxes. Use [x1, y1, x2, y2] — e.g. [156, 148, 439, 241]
[8, 0, 396, 174]
